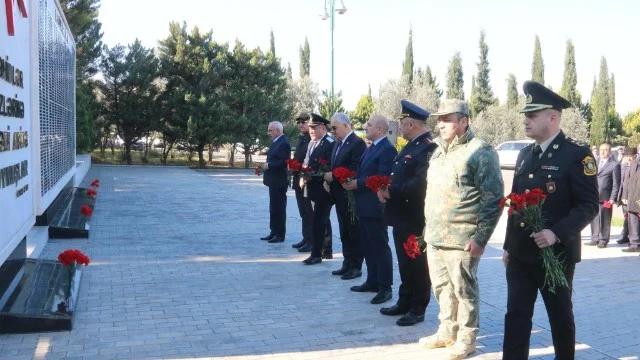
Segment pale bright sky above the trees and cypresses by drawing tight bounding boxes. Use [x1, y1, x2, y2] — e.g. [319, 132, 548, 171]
[99, 0, 640, 116]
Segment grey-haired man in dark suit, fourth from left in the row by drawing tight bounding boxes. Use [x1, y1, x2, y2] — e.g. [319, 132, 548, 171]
[324, 113, 367, 280]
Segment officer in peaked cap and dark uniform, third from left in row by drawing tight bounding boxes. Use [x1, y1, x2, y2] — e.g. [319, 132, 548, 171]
[303, 113, 335, 265]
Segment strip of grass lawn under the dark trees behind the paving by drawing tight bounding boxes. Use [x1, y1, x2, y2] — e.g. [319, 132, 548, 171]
[91, 149, 257, 169]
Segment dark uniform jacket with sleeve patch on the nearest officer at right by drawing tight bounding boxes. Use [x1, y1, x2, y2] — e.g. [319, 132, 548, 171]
[504, 132, 598, 264]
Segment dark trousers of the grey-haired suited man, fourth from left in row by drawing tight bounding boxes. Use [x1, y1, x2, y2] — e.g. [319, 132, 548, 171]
[333, 191, 364, 270]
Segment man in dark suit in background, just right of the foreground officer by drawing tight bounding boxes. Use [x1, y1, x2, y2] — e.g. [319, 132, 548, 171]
[585, 143, 620, 248]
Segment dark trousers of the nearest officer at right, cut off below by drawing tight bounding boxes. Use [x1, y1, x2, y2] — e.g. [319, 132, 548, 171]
[502, 257, 576, 360]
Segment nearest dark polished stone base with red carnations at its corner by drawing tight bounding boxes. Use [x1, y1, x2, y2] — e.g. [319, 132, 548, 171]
[0, 259, 82, 333]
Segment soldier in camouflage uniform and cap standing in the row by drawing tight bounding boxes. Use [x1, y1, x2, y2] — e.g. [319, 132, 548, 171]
[420, 99, 504, 359]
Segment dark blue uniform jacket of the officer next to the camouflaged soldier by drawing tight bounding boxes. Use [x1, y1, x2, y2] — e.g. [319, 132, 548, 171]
[384, 132, 438, 228]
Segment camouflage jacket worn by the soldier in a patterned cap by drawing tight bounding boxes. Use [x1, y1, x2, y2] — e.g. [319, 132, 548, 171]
[424, 130, 504, 249]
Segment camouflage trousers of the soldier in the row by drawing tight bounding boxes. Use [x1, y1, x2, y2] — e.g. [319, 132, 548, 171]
[427, 245, 480, 344]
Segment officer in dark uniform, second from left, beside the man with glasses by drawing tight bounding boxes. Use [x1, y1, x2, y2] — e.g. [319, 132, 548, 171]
[291, 113, 312, 249]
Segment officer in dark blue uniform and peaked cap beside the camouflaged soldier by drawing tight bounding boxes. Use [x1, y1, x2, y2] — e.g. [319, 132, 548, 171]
[378, 100, 437, 326]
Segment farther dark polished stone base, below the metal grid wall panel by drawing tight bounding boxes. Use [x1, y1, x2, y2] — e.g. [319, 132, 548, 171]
[47, 188, 95, 239]
